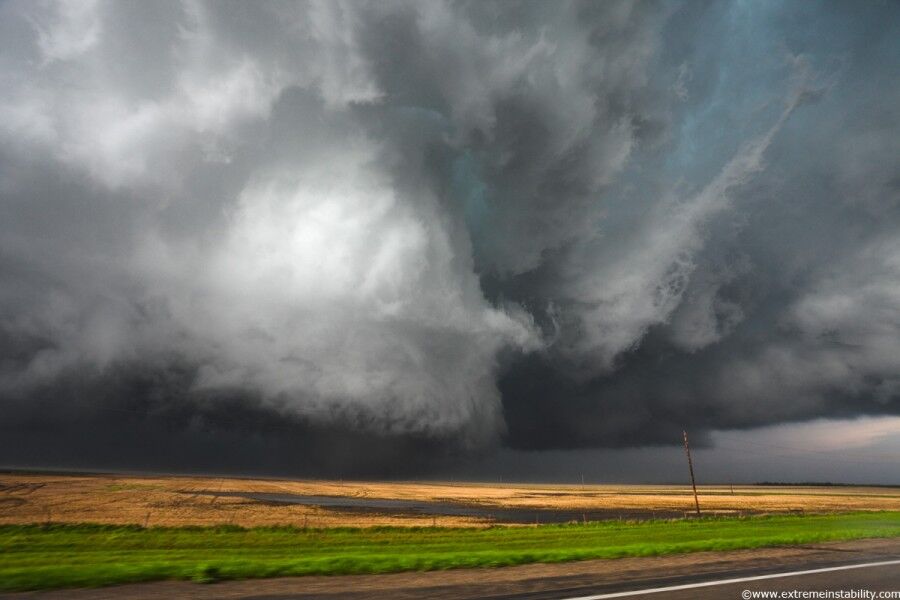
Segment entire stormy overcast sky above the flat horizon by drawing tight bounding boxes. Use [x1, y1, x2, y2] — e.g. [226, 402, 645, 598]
[0, 0, 900, 483]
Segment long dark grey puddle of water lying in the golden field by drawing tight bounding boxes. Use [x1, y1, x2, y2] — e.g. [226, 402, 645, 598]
[200, 492, 684, 524]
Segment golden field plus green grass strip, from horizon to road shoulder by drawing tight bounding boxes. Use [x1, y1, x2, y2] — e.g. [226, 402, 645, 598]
[0, 472, 900, 591]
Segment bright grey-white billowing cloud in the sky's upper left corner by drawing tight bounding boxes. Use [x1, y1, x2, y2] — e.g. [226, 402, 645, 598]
[0, 2, 378, 188]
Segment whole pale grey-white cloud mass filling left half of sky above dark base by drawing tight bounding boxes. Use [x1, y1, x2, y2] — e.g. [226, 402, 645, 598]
[0, 2, 539, 441]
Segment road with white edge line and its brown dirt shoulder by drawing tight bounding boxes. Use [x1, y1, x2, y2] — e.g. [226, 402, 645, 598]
[9, 539, 900, 600]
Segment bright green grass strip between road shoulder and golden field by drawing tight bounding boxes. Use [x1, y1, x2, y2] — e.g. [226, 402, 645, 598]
[0, 512, 900, 591]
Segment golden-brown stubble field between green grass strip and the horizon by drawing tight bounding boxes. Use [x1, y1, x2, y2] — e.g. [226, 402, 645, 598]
[0, 472, 900, 527]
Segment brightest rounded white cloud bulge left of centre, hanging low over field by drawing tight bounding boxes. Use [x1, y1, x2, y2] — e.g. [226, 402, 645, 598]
[136, 142, 537, 433]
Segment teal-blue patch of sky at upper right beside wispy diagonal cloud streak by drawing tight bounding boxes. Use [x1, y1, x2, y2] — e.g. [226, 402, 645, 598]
[601, 0, 792, 244]
